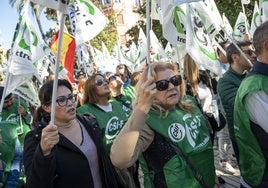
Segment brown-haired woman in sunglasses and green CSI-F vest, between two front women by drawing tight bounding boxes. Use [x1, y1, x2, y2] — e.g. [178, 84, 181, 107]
[77, 74, 137, 188]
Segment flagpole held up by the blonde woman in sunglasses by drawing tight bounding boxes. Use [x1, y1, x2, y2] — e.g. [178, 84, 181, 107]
[146, 0, 151, 75]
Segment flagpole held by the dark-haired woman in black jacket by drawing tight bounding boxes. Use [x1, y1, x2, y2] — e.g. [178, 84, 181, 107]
[50, 13, 66, 124]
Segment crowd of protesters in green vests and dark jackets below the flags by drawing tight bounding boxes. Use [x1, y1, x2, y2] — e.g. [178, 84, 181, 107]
[0, 22, 268, 188]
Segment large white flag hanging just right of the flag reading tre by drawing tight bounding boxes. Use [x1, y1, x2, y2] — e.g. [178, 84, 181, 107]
[186, 5, 220, 74]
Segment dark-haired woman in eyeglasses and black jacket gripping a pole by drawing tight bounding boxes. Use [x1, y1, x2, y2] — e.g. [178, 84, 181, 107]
[23, 80, 122, 188]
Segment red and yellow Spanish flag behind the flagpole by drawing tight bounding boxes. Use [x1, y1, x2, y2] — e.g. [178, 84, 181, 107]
[50, 31, 75, 83]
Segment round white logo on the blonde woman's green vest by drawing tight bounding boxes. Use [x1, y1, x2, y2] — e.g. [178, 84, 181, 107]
[168, 123, 185, 142]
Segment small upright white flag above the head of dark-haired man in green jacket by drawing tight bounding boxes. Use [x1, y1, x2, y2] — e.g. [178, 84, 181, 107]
[233, 12, 248, 41]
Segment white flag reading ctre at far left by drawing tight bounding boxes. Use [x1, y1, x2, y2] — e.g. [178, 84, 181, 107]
[6, 3, 45, 93]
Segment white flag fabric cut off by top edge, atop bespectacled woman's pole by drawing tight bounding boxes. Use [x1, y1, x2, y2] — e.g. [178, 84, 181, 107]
[31, 0, 69, 14]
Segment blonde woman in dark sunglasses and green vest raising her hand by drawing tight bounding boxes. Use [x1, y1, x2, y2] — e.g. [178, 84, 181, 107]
[110, 62, 215, 188]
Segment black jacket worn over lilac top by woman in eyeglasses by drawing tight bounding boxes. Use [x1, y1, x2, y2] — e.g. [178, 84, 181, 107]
[23, 116, 120, 188]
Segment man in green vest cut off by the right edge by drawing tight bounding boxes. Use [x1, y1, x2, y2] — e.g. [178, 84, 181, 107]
[234, 21, 268, 187]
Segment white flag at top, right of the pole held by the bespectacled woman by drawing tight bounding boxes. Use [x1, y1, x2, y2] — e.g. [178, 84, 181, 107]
[68, 0, 109, 45]
